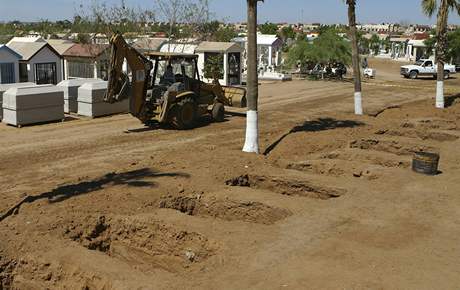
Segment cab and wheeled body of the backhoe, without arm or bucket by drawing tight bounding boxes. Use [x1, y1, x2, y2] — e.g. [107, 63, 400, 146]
[147, 53, 229, 129]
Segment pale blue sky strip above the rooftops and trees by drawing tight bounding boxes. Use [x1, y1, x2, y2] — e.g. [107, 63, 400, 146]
[0, 0, 460, 24]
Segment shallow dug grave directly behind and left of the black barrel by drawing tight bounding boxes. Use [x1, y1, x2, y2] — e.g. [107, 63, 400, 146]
[350, 139, 438, 155]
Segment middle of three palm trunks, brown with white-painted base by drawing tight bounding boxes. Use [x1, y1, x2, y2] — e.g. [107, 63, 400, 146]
[346, 0, 363, 115]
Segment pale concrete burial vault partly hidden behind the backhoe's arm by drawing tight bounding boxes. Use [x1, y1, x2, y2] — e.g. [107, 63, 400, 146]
[78, 81, 129, 118]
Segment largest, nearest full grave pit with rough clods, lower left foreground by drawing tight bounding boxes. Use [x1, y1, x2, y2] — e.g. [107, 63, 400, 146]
[65, 216, 214, 269]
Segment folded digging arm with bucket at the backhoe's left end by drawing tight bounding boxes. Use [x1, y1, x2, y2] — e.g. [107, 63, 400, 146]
[104, 34, 153, 123]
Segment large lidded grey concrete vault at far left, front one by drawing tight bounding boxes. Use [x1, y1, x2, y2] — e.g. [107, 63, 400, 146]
[3, 85, 64, 127]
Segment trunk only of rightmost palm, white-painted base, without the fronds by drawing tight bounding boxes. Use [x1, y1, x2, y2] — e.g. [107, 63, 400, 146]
[436, 0, 449, 109]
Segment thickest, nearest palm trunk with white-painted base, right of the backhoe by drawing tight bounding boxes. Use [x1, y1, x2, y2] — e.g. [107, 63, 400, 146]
[243, 0, 259, 153]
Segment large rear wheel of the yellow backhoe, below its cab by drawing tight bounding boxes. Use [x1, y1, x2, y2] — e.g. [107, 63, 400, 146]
[170, 97, 197, 130]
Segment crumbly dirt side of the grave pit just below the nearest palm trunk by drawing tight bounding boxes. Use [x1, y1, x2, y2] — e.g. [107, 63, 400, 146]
[251, 176, 346, 199]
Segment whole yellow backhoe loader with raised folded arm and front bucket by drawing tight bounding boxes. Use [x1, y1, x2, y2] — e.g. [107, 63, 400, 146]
[104, 34, 246, 129]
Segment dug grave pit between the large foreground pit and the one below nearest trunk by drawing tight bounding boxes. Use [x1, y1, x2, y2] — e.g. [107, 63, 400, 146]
[159, 196, 291, 224]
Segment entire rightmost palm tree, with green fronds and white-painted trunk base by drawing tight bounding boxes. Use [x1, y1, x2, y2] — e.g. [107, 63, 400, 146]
[422, 0, 460, 109]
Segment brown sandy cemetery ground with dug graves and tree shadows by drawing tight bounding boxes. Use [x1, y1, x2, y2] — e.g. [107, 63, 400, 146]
[0, 59, 460, 289]
